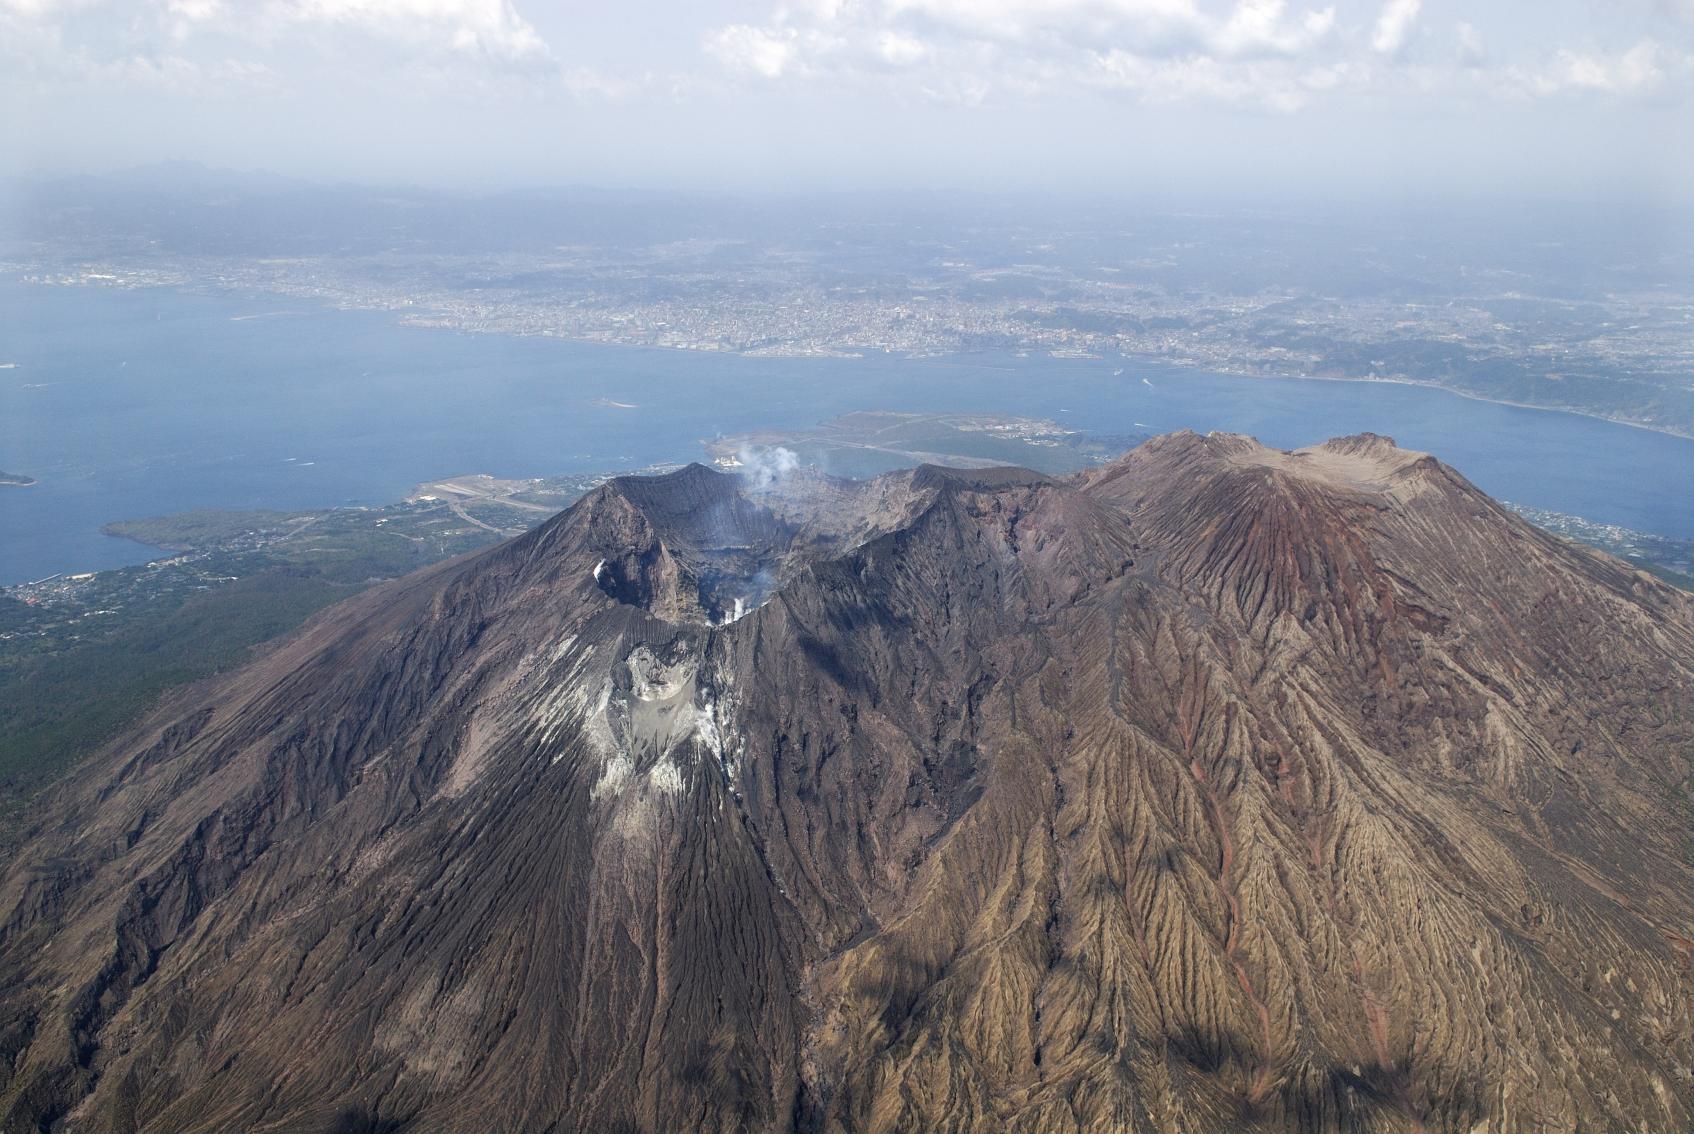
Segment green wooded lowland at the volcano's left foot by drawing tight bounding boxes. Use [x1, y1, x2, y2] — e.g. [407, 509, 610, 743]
[0, 503, 521, 848]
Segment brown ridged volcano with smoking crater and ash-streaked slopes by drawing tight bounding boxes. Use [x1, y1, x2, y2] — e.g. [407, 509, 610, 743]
[0, 434, 1694, 1132]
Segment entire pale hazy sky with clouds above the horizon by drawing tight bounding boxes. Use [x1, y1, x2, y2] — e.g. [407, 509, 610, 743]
[0, 0, 1694, 202]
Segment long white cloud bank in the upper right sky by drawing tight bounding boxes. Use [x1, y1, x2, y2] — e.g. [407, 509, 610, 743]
[705, 0, 1694, 114]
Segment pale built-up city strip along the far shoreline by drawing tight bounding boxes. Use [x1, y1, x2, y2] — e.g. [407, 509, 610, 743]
[14, 254, 1694, 436]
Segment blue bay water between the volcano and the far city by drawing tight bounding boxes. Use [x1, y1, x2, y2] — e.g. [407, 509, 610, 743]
[0, 280, 1694, 583]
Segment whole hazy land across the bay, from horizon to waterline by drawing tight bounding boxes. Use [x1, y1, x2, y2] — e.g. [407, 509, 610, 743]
[0, 186, 1694, 436]
